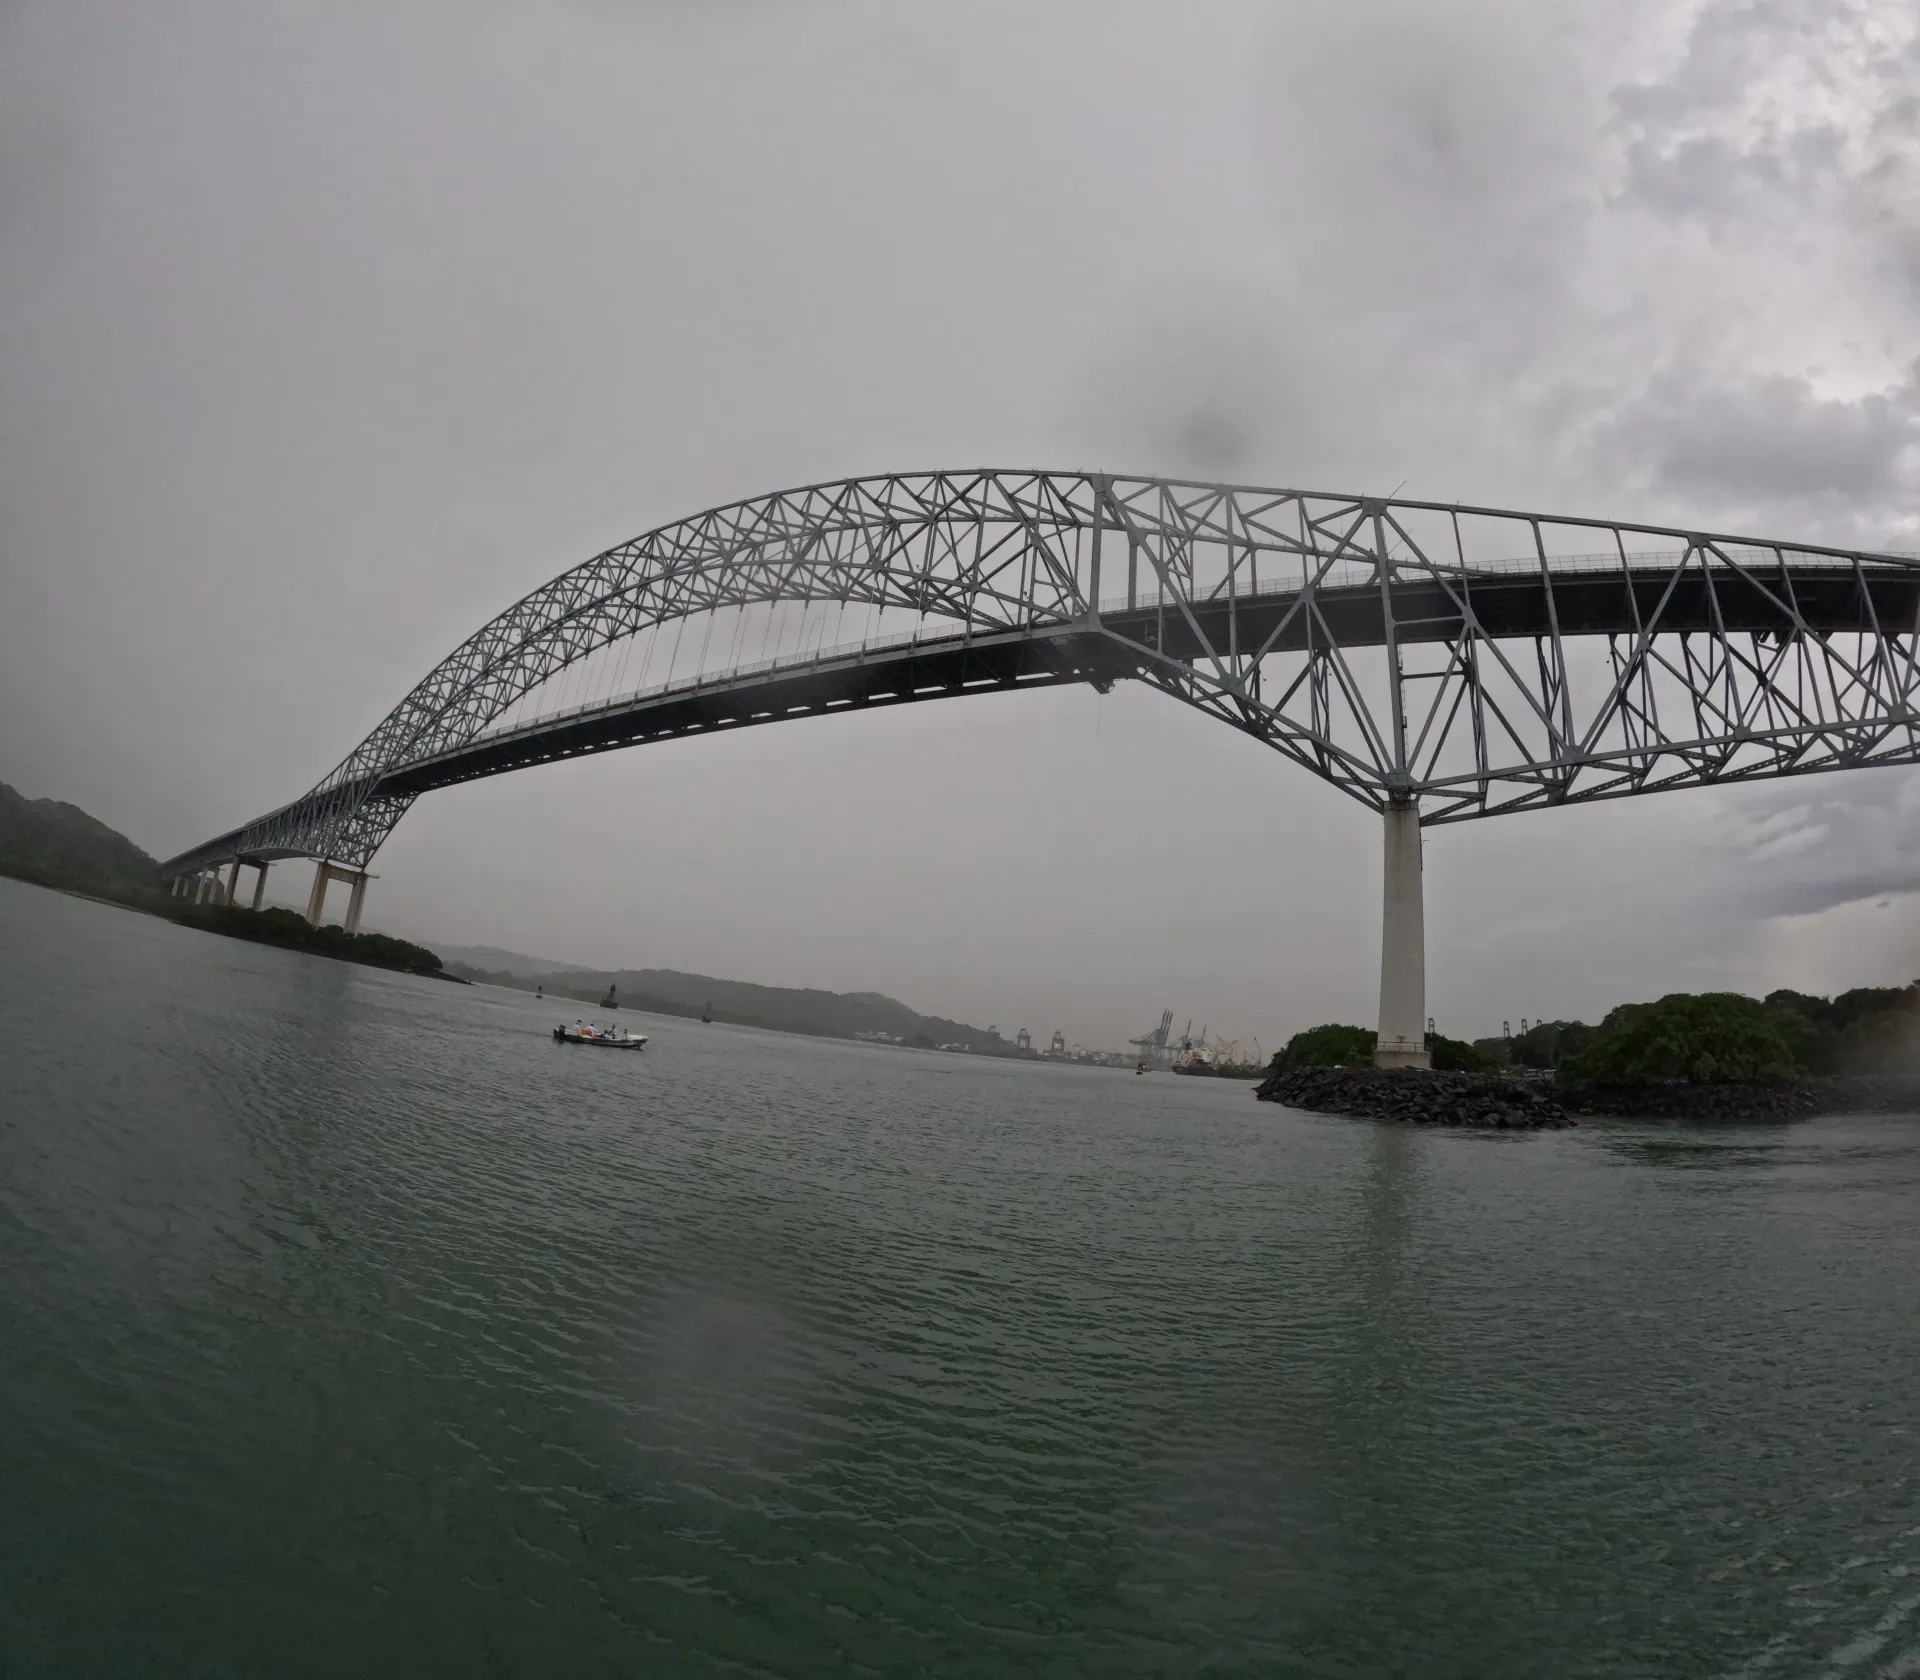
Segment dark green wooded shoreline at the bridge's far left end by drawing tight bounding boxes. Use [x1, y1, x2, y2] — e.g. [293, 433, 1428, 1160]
[0, 781, 440, 973]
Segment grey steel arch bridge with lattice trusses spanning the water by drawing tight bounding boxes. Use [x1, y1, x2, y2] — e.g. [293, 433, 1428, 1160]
[163, 468, 1920, 1060]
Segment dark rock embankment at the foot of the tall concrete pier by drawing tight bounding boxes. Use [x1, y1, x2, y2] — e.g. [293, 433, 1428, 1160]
[1254, 1068, 1920, 1131]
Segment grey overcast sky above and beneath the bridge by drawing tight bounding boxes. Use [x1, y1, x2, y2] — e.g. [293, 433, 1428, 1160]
[0, 0, 1920, 1050]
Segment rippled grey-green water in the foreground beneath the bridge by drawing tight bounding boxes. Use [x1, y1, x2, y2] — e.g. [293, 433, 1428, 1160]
[0, 881, 1920, 1676]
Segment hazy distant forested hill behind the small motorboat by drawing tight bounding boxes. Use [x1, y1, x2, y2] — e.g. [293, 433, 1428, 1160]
[449, 967, 998, 1048]
